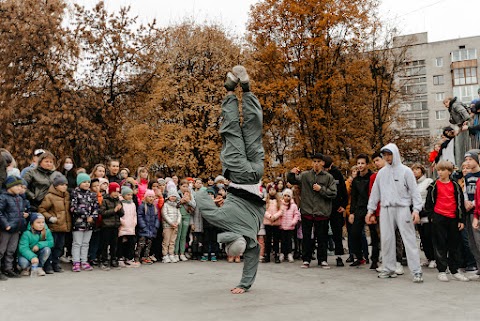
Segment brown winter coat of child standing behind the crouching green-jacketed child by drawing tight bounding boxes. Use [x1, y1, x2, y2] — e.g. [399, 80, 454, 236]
[38, 185, 72, 232]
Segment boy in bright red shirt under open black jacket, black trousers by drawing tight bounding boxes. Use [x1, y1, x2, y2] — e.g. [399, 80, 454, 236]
[425, 161, 469, 282]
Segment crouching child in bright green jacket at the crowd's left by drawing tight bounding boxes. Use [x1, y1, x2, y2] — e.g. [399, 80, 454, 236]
[18, 213, 53, 276]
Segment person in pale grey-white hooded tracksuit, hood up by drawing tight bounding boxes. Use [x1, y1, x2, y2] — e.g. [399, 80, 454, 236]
[365, 144, 423, 283]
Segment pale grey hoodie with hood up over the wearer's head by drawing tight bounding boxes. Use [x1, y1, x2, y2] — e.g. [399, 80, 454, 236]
[368, 144, 423, 213]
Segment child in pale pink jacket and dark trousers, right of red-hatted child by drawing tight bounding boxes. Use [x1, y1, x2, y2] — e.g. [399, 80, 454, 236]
[118, 186, 140, 267]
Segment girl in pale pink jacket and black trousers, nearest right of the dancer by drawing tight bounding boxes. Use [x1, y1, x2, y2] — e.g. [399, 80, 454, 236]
[263, 183, 283, 263]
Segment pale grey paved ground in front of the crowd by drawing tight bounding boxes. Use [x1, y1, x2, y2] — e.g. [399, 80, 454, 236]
[0, 257, 480, 321]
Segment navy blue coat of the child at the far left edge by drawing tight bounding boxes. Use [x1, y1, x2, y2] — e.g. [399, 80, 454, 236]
[0, 191, 27, 233]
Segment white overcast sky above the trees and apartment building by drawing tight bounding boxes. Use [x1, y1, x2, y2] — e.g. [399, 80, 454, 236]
[67, 0, 480, 41]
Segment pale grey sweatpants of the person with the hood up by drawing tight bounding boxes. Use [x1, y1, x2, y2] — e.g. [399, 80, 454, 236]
[380, 206, 422, 274]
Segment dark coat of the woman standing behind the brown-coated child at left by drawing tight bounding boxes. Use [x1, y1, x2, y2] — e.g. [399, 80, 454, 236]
[23, 167, 62, 211]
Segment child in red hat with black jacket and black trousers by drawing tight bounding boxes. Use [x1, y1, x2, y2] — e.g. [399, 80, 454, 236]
[100, 182, 125, 271]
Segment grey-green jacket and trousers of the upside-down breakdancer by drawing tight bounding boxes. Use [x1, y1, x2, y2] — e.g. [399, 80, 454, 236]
[195, 92, 265, 290]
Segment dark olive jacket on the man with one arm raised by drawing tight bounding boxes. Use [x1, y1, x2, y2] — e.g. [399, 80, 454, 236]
[287, 170, 337, 218]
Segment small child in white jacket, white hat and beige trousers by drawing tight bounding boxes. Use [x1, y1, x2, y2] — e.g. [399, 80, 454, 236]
[162, 188, 182, 263]
